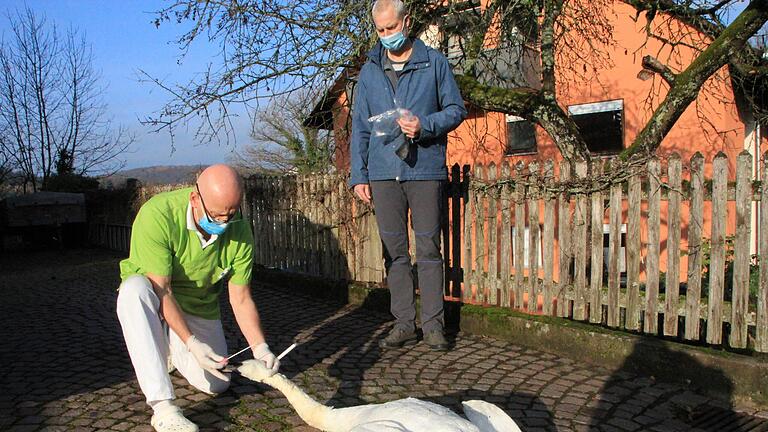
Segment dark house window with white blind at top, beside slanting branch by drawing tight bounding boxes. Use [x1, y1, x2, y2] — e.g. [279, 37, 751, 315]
[568, 100, 624, 154]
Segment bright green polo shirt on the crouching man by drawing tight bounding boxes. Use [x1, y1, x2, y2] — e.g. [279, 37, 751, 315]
[120, 188, 253, 319]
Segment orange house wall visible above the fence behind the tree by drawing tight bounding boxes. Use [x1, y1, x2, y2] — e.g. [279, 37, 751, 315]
[448, 2, 744, 168]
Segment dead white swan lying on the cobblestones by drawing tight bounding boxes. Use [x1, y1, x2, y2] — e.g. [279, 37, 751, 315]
[238, 360, 520, 432]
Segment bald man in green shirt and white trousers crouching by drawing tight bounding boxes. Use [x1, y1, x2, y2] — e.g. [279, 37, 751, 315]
[117, 165, 279, 432]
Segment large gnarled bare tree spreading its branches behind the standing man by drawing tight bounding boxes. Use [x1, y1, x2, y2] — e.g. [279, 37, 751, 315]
[148, 0, 768, 165]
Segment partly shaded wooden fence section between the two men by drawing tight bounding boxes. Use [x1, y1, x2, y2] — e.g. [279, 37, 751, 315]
[243, 175, 376, 282]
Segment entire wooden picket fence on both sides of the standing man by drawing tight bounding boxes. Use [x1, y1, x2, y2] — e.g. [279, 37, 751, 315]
[244, 152, 768, 352]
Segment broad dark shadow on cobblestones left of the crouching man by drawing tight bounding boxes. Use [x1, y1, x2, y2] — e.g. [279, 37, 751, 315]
[0, 249, 140, 429]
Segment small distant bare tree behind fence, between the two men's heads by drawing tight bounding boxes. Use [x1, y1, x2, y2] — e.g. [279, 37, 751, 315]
[234, 91, 334, 174]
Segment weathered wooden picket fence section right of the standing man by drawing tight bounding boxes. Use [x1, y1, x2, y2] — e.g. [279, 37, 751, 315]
[463, 153, 768, 352]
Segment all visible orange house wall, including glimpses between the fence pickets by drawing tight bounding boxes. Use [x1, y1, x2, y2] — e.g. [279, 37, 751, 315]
[334, 2, 768, 290]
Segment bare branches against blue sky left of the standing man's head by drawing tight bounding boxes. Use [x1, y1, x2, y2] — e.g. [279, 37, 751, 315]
[141, 0, 370, 148]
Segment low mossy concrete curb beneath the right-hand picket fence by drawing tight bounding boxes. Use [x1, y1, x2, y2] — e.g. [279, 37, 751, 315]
[461, 306, 768, 407]
